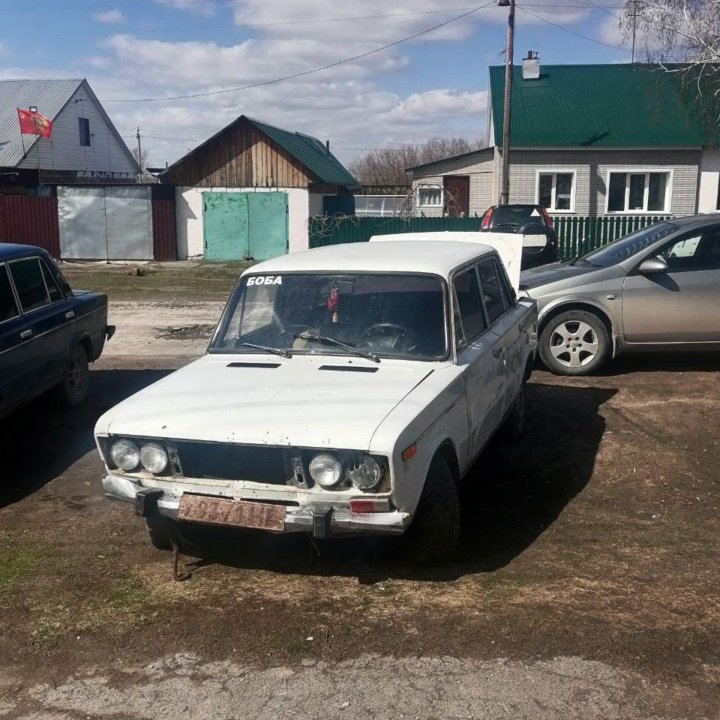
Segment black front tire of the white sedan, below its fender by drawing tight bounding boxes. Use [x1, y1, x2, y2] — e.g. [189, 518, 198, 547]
[406, 455, 460, 565]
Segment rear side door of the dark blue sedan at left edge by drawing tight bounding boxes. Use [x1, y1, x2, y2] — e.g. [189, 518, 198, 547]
[10, 257, 75, 386]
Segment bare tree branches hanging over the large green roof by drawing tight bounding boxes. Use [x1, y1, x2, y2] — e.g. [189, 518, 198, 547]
[619, 0, 720, 127]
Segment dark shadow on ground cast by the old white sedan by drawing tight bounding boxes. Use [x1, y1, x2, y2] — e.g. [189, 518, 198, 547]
[174, 383, 616, 583]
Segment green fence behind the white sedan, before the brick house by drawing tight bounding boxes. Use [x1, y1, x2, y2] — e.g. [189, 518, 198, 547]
[309, 215, 669, 260]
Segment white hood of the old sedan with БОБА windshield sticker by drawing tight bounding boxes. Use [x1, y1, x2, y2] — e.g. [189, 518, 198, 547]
[95, 354, 434, 450]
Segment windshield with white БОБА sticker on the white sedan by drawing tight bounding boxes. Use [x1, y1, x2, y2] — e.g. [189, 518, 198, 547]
[210, 273, 447, 360]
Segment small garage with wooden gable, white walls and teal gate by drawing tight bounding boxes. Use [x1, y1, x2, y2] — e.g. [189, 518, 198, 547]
[160, 115, 358, 260]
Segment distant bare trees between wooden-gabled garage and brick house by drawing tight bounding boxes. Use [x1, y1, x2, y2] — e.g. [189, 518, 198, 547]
[348, 137, 482, 186]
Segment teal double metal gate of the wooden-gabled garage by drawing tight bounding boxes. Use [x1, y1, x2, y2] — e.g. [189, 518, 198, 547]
[203, 192, 288, 261]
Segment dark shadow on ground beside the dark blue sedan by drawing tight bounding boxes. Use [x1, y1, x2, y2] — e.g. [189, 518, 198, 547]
[0, 370, 171, 508]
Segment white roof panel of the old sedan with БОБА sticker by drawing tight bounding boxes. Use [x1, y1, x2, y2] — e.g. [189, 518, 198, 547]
[246, 240, 496, 277]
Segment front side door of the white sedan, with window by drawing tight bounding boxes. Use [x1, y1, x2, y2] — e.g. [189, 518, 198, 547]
[453, 265, 504, 461]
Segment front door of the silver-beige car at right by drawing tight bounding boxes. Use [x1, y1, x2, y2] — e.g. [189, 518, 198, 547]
[622, 224, 720, 343]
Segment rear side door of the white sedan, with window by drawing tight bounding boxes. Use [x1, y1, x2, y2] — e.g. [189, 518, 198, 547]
[478, 257, 522, 422]
